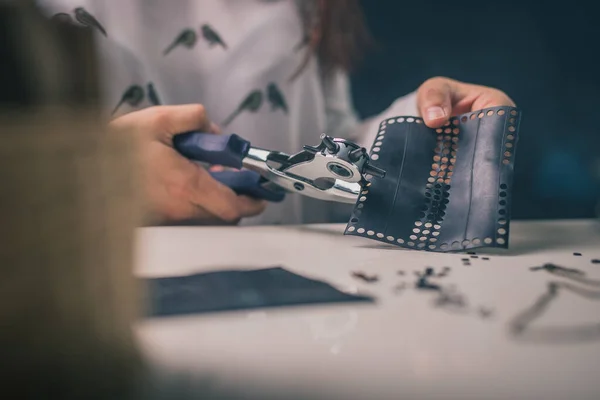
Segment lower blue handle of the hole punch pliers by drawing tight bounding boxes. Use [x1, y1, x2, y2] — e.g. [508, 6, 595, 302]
[210, 170, 285, 203]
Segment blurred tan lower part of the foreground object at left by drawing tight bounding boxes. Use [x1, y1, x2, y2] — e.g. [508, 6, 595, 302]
[0, 114, 139, 399]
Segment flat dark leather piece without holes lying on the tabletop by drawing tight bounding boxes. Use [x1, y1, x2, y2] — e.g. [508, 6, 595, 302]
[145, 267, 374, 317]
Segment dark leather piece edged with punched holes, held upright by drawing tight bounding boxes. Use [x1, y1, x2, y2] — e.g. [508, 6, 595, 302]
[345, 107, 521, 252]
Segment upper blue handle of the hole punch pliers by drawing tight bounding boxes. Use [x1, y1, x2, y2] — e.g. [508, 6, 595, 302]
[173, 132, 250, 169]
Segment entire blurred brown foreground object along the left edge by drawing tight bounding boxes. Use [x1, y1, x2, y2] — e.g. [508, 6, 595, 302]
[0, 1, 141, 399]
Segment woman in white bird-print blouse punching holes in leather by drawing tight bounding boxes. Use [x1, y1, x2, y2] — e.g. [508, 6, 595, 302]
[40, 0, 513, 224]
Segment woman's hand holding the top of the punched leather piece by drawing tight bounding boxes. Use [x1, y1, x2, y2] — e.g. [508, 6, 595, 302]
[417, 77, 515, 128]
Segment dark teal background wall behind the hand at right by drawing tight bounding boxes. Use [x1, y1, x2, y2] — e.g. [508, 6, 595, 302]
[353, 0, 600, 219]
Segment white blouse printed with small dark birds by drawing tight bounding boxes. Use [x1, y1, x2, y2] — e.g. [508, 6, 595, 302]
[38, 0, 418, 225]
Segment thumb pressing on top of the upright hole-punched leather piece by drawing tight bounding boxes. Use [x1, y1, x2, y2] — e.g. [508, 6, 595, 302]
[417, 78, 452, 128]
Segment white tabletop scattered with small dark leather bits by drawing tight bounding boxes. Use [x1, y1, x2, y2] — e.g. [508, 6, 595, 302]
[136, 221, 600, 400]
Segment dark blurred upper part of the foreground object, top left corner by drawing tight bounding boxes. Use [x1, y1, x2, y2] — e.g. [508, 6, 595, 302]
[0, 0, 100, 108]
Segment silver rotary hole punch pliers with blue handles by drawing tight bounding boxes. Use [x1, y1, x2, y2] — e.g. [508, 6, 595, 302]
[173, 132, 385, 204]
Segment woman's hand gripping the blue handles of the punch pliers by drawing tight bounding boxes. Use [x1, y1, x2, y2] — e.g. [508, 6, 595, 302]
[110, 105, 266, 224]
